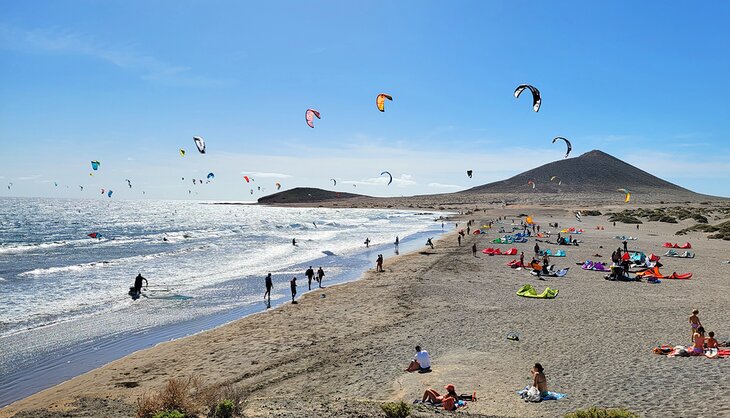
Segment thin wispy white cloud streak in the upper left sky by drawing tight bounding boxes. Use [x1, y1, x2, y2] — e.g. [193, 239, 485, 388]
[0, 23, 230, 86]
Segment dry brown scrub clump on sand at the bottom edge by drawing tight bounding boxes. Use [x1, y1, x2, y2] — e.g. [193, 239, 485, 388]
[137, 376, 243, 418]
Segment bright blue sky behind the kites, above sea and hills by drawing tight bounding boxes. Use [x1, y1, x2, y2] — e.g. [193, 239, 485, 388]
[0, 0, 730, 201]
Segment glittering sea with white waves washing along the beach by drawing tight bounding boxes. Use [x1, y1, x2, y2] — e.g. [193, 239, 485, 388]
[0, 198, 442, 405]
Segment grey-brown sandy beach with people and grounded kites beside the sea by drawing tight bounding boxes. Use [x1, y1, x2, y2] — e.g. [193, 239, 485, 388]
[0, 207, 730, 417]
